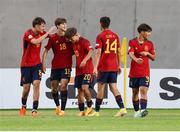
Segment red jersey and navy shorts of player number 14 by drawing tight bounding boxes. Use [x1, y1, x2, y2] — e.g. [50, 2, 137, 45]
[96, 29, 120, 83]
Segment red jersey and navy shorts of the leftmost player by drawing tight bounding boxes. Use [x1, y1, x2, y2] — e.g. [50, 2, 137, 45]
[20, 29, 45, 86]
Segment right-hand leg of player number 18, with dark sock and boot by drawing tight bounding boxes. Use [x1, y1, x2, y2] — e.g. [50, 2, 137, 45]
[59, 79, 69, 116]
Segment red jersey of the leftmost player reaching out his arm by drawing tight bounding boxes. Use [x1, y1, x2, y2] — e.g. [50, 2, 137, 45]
[21, 29, 45, 67]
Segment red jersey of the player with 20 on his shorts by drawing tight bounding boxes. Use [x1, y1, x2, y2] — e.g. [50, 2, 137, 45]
[73, 37, 94, 76]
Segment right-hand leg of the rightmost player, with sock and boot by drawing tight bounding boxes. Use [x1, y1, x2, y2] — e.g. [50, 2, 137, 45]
[139, 86, 148, 117]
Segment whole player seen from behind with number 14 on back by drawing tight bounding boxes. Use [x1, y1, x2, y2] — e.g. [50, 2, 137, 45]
[92, 17, 127, 116]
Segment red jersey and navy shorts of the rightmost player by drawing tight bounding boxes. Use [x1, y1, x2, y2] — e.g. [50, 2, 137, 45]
[128, 38, 155, 88]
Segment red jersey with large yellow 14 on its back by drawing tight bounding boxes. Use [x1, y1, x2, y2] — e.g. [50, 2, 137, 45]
[96, 30, 120, 72]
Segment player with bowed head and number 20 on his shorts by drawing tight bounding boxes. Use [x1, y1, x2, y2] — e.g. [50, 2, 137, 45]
[65, 28, 93, 116]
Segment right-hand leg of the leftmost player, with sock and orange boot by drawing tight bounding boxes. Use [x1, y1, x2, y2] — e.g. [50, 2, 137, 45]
[32, 80, 41, 116]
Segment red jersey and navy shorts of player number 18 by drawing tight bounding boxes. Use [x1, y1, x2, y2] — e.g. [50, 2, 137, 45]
[45, 33, 74, 81]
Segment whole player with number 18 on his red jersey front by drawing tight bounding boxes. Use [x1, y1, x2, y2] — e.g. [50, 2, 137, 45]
[42, 18, 74, 116]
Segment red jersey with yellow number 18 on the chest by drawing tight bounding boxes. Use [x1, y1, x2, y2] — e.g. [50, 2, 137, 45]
[45, 33, 73, 69]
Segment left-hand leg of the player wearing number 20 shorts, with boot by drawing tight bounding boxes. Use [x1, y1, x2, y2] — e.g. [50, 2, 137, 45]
[78, 88, 85, 116]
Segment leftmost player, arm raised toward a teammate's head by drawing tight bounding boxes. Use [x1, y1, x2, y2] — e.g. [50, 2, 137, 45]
[20, 17, 56, 116]
